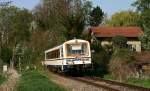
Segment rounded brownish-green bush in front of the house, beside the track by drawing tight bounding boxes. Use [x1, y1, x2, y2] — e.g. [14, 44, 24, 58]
[109, 49, 135, 80]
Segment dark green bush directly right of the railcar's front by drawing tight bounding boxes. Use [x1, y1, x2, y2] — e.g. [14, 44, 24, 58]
[90, 40, 111, 77]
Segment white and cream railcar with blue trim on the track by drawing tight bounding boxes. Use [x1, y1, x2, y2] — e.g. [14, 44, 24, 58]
[42, 39, 91, 71]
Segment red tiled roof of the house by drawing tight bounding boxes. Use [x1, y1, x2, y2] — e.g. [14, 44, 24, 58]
[91, 27, 143, 37]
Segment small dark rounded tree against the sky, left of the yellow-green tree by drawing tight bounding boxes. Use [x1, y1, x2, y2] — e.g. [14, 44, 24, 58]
[90, 6, 104, 26]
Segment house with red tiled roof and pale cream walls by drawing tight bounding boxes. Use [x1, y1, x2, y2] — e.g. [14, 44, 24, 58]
[90, 27, 143, 52]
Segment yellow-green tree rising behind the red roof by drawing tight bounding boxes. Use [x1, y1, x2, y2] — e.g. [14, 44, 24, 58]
[106, 11, 140, 27]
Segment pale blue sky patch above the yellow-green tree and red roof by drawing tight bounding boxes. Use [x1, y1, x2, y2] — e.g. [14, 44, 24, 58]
[92, 0, 136, 15]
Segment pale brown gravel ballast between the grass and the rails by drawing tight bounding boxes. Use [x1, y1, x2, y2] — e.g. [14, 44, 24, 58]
[51, 74, 107, 91]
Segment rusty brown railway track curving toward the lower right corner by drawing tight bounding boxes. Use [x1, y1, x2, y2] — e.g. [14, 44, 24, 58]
[52, 74, 150, 91]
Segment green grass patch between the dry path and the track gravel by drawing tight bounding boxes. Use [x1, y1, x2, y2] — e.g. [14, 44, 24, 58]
[16, 71, 66, 91]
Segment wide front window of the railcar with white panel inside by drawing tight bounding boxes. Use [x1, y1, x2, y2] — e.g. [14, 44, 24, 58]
[67, 44, 87, 56]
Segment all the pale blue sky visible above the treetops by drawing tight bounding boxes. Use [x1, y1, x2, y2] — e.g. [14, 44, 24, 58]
[6, 0, 135, 15]
